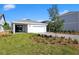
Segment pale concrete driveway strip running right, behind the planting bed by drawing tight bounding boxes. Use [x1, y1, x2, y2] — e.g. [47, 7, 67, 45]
[41, 33, 79, 40]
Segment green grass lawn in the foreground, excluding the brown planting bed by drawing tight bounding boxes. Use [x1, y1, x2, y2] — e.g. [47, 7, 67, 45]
[0, 34, 79, 55]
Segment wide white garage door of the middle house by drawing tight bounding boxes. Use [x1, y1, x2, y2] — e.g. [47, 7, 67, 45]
[28, 25, 46, 33]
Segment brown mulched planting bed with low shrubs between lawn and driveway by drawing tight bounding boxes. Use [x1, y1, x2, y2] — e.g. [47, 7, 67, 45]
[33, 34, 79, 45]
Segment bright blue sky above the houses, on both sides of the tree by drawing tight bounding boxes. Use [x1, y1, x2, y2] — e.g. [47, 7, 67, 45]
[0, 4, 79, 22]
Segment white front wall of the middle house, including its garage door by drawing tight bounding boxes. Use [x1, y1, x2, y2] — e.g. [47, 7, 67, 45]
[12, 23, 46, 34]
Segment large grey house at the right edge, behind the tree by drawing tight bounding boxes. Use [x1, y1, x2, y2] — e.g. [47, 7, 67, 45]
[60, 11, 79, 32]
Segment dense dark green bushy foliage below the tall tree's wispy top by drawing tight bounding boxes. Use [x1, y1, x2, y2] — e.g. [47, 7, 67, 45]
[47, 20, 64, 32]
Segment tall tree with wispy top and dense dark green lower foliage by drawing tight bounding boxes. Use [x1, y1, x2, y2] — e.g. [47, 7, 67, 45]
[47, 5, 64, 32]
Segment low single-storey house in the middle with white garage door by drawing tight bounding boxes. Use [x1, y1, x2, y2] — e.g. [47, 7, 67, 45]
[12, 19, 47, 33]
